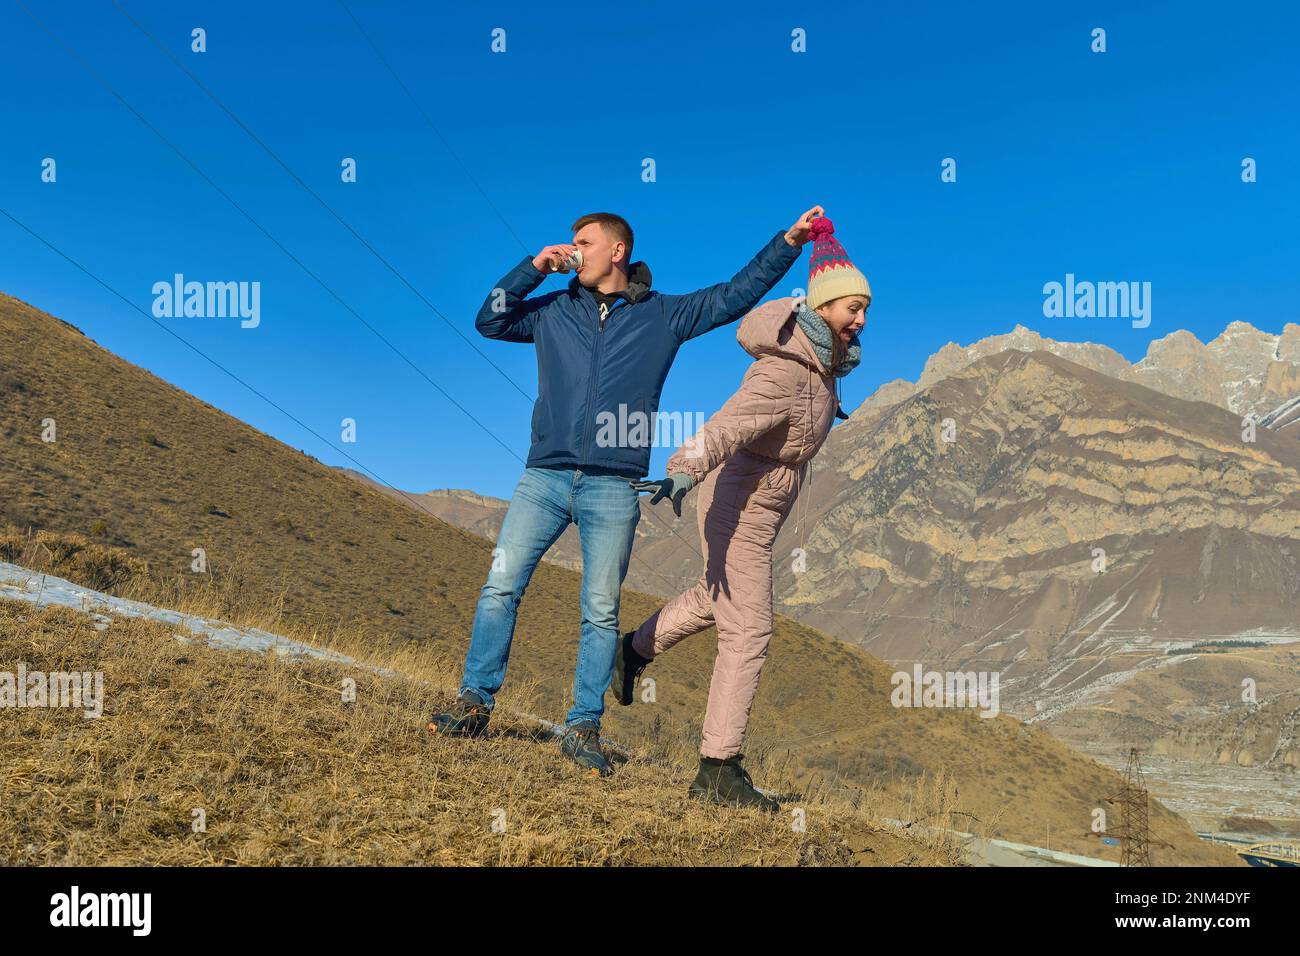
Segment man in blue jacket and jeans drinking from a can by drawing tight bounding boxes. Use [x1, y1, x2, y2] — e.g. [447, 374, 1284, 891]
[428, 207, 823, 775]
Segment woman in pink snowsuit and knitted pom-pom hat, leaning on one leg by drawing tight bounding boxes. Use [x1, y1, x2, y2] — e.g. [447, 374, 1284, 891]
[611, 219, 871, 812]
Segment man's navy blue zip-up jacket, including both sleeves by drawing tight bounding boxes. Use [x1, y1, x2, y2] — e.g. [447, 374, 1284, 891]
[475, 232, 801, 479]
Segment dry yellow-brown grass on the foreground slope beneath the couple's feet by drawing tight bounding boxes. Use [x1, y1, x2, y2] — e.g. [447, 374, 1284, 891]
[0, 601, 953, 865]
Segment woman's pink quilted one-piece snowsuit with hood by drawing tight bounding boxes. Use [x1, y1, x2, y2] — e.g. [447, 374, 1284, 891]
[632, 299, 839, 760]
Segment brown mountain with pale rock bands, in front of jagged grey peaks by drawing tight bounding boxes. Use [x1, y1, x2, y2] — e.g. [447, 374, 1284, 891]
[776, 351, 1300, 650]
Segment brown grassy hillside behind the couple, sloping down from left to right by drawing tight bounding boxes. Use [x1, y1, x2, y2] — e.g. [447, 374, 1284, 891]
[0, 297, 1231, 864]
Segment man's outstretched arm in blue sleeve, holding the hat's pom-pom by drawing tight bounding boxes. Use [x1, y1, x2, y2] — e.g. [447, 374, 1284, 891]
[668, 206, 826, 342]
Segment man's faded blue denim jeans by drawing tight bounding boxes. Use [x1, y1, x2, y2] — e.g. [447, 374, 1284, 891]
[460, 468, 641, 726]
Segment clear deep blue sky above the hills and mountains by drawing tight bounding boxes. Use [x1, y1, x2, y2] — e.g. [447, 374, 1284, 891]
[0, 0, 1300, 497]
